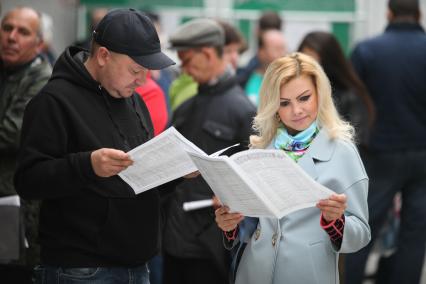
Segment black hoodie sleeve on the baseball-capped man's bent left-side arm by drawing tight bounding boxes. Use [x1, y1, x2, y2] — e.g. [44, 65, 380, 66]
[14, 93, 113, 199]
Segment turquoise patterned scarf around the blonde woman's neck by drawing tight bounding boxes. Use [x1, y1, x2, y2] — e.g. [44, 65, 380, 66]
[274, 121, 319, 162]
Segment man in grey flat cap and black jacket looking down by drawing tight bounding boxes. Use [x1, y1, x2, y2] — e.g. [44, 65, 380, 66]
[163, 19, 256, 284]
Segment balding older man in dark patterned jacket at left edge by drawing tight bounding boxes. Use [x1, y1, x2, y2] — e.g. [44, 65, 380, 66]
[0, 7, 51, 283]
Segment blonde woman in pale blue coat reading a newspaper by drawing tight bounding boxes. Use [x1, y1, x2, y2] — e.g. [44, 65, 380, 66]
[215, 53, 370, 284]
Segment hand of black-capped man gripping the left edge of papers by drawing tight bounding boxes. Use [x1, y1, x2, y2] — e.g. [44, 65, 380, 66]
[90, 148, 133, 177]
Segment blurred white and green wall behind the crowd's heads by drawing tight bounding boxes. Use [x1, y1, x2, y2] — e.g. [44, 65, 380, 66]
[2, 0, 426, 63]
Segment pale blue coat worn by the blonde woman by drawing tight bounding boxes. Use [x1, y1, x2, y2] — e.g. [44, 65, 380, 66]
[236, 130, 370, 284]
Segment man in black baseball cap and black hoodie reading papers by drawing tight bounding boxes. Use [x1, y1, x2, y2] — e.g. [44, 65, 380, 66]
[15, 9, 174, 284]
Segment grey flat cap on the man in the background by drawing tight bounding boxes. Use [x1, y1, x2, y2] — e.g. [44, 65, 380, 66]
[169, 19, 225, 50]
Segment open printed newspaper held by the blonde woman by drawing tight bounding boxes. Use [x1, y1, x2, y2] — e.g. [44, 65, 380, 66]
[189, 150, 334, 218]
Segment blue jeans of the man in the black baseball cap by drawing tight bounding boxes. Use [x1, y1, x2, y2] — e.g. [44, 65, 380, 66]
[34, 265, 149, 284]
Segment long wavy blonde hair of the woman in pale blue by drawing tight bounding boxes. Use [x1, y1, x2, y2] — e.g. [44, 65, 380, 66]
[250, 52, 354, 148]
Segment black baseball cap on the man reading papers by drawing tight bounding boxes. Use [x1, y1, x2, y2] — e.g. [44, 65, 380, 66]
[93, 9, 175, 70]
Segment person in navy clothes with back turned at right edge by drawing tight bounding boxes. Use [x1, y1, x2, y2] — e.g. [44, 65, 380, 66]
[346, 0, 426, 284]
